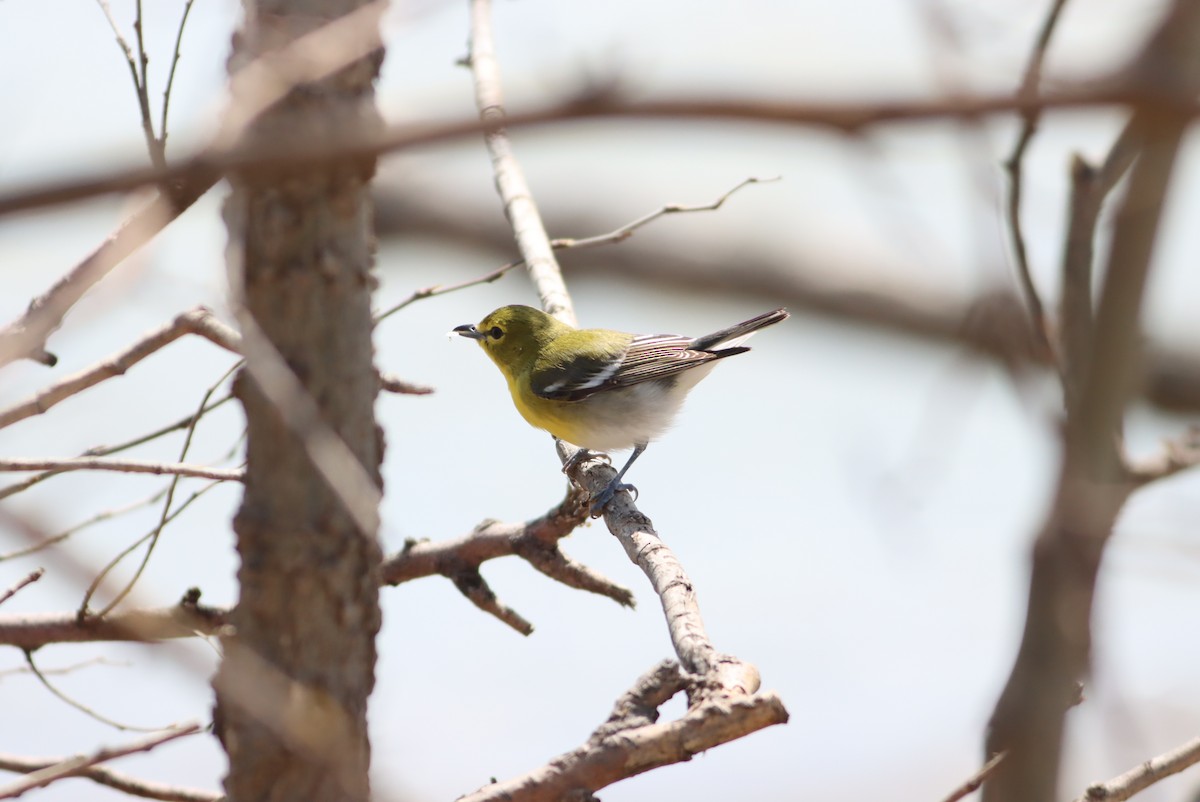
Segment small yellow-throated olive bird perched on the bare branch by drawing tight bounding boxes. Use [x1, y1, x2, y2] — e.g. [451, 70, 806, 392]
[454, 306, 787, 515]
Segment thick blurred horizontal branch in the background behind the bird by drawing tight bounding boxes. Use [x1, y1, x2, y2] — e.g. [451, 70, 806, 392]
[376, 181, 1200, 412]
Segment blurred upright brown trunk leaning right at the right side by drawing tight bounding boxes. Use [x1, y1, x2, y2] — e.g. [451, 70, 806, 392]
[983, 0, 1200, 802]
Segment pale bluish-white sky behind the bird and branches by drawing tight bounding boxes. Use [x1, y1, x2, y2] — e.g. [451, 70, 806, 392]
[0, 0, 1200, 802]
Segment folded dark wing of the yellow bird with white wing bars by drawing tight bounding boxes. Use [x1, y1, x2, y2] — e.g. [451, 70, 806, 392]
[530, 334, 749, 401]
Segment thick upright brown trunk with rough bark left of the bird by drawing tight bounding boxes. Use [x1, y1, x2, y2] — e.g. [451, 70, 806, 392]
[215, 0, 383, 801]
